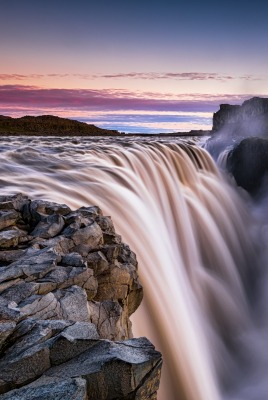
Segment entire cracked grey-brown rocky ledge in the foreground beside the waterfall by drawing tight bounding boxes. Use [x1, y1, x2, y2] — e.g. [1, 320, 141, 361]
[0, 194, 162, 400]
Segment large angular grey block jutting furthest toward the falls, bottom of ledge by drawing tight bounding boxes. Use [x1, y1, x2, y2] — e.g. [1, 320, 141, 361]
[44, 338, 162, 400]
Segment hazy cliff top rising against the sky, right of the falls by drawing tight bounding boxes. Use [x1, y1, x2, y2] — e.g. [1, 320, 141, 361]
[212, 97, 268, 136]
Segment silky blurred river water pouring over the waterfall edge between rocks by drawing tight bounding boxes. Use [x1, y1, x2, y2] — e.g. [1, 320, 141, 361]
[0, 138, 265, 400]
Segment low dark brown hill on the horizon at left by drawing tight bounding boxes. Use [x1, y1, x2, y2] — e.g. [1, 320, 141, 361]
[0, 115, 121, 136]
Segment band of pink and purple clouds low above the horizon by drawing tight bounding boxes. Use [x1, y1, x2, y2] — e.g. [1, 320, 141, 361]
[0, 85, 258, 132]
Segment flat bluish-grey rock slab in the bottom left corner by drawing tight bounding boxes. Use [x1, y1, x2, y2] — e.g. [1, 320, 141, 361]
[0, 378, 87, 400]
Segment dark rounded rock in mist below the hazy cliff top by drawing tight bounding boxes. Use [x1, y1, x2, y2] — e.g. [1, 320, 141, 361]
[227, 138, 268, 196]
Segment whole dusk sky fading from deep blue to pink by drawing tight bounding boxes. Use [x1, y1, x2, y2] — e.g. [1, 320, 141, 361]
[0, 0, 268, 133]
